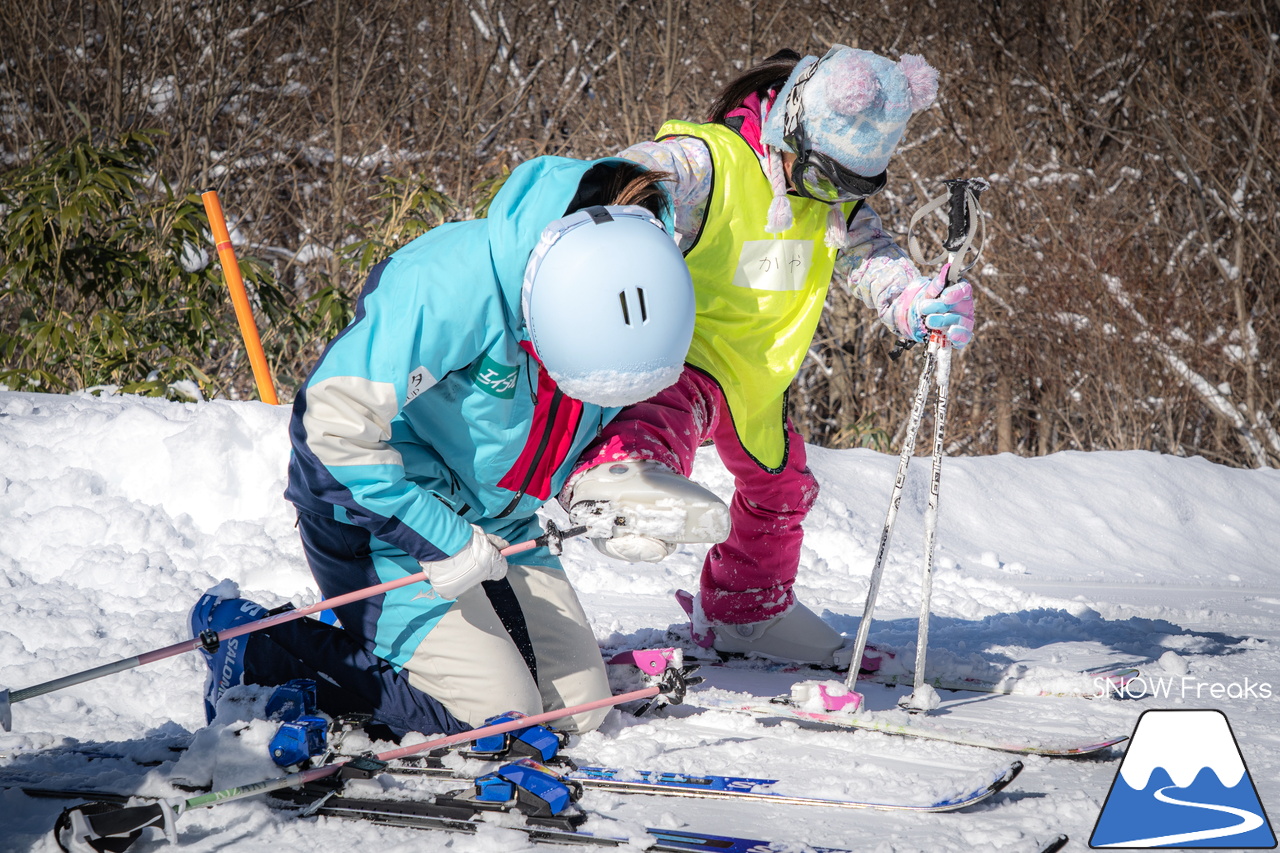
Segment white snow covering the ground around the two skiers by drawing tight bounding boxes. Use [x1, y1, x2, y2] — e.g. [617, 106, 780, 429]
[0, 393, 1280, 853]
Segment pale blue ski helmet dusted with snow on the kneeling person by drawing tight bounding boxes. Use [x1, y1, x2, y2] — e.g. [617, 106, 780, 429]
[521, 205, 695, 406]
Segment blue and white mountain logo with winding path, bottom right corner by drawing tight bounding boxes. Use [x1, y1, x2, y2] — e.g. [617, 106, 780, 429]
[1089, 711, 1276, 850]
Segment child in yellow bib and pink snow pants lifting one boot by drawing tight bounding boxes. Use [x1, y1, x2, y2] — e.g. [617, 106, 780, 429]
[561, 45, 973, 667]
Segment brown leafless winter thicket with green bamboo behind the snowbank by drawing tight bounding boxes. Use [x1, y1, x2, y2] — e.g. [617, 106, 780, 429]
[0, 0, 1280, 466]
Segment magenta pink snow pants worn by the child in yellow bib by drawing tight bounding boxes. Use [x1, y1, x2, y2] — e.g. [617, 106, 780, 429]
[575, 365, 818, 625]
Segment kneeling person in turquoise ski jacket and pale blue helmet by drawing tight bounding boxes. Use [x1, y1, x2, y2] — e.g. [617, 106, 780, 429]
[192, 158, 695, 736]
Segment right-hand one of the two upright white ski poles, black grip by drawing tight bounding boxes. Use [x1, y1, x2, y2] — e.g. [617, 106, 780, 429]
[899, 178, 987, 712]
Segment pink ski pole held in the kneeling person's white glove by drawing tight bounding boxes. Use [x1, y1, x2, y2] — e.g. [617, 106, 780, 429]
[0, 521, 586, 731]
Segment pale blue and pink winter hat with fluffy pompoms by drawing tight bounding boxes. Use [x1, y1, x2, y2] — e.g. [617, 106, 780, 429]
[760, 45, 938, 178]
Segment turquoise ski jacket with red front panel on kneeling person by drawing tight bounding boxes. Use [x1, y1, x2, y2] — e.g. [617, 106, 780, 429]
[285, 158, 640, 564]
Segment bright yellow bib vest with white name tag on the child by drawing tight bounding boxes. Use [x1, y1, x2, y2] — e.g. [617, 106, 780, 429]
[658, 120, 859, 471]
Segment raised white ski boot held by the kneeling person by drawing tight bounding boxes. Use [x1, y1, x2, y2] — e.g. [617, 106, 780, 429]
[568, 460, 730, 562]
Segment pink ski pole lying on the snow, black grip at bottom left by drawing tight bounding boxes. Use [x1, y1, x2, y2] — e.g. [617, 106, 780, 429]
[54, 667, 686, 850]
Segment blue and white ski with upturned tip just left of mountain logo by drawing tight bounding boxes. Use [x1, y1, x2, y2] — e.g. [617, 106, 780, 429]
[368, 742, 1023, 812]
